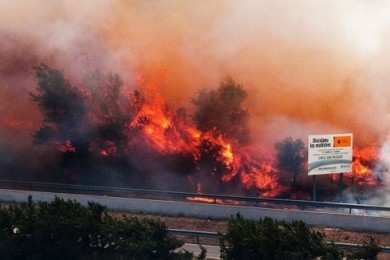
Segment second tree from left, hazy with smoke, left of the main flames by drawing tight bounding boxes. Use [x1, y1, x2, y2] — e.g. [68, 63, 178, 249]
[86, 71, 144, 160]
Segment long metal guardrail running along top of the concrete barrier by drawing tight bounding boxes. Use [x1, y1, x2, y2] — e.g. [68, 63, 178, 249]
[0, 180, 390, 215]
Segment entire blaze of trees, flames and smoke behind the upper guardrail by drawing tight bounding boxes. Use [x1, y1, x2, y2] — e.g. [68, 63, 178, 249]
[0, 0, 390, 202]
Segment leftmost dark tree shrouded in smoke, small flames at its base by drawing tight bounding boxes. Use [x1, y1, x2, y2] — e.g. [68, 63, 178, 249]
[30, 64, 91, 168]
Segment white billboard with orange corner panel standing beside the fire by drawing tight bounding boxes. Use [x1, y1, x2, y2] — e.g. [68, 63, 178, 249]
[308, 133, 353, 175]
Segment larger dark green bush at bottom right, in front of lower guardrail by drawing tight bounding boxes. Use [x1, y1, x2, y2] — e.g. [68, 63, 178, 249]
[220, 214, 341, 259]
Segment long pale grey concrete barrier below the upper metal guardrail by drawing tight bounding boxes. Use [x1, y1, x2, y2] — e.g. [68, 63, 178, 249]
[0, 189, 390, 233]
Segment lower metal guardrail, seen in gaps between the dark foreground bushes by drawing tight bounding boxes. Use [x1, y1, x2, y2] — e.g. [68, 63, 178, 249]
[168, 229, 390, 253]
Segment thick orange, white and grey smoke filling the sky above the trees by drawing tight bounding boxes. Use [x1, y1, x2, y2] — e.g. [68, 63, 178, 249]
[0, 0, 390, 201]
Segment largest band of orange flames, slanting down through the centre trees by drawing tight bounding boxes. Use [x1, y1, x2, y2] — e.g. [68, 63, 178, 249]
[124, 75, 290, 198]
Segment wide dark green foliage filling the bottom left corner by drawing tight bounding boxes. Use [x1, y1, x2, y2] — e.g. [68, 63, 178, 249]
[0, 197, 192, 259]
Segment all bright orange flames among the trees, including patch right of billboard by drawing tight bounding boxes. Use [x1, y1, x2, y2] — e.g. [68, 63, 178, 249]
[42, 69, 379, 199]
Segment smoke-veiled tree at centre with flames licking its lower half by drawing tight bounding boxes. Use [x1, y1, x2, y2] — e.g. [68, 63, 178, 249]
[192, 77, 249, 193]
